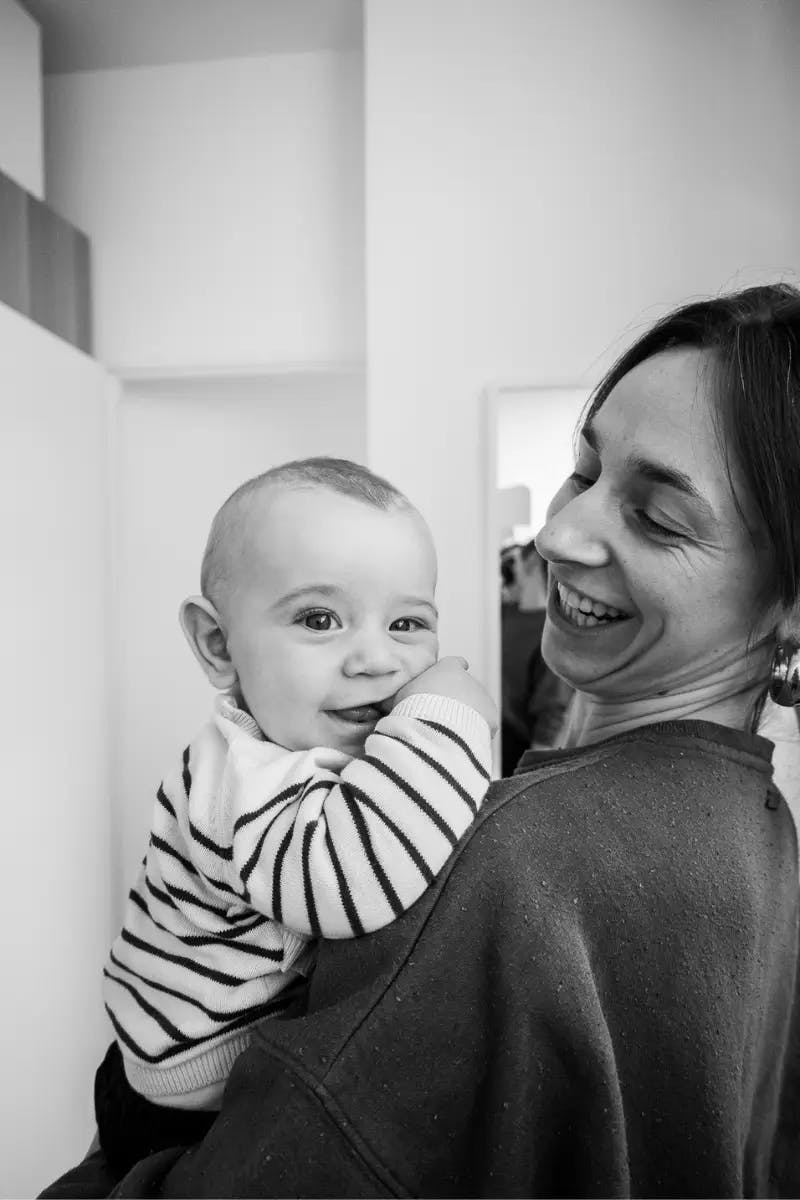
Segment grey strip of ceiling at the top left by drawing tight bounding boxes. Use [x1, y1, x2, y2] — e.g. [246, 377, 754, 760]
[20, 0, 363, 74]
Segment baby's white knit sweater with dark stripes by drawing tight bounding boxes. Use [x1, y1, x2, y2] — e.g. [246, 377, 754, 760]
[103, 695, 491, 1108]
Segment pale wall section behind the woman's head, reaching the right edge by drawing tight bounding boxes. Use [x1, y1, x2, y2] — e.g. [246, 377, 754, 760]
[365, 0, 800, 691]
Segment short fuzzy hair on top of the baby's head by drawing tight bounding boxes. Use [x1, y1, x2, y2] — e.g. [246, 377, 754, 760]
[200, 457, 413, 605]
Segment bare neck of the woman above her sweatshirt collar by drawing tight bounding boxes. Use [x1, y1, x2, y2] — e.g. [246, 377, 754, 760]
[560, 679, 763, 746]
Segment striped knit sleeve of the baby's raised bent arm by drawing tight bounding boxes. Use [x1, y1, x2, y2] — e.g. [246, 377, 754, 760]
[219, 694, 491, 937]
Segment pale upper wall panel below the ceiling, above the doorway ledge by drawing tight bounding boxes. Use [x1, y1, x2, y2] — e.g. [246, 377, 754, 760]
[46, 52, 363, 370]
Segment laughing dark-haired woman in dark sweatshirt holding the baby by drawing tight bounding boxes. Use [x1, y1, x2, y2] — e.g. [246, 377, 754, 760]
[42, 286, 800, 1196]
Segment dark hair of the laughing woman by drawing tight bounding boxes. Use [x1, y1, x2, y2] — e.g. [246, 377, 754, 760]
[582, 283, 800, 608]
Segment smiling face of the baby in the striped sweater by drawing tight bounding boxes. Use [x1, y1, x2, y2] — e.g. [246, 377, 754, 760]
[225, 487, 439, 755]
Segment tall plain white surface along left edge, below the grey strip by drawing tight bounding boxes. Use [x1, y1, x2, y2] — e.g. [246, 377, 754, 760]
[0, 305, 113, 1196]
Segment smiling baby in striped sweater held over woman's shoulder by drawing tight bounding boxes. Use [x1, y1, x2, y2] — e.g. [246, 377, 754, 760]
[98, 458, 497, 1152]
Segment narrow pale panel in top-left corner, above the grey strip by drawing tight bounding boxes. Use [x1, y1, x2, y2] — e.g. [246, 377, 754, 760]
[0, 0, 44, 200]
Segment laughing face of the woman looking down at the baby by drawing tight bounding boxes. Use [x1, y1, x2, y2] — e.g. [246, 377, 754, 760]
[536, 348, 774, 700]
